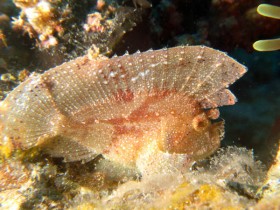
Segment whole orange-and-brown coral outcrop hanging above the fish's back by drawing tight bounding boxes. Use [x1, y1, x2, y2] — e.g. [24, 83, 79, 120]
[13, 0, 145, 59]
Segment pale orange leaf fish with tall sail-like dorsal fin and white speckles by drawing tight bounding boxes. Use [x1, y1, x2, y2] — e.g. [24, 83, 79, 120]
[0, 46, 246, 176]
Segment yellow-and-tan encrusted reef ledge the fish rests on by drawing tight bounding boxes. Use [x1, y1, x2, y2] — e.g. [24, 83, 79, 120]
[0, 147, 262, 209]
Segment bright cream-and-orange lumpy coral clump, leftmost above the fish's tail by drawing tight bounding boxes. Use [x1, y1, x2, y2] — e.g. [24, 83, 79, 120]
[13, 0, 71, 48]
